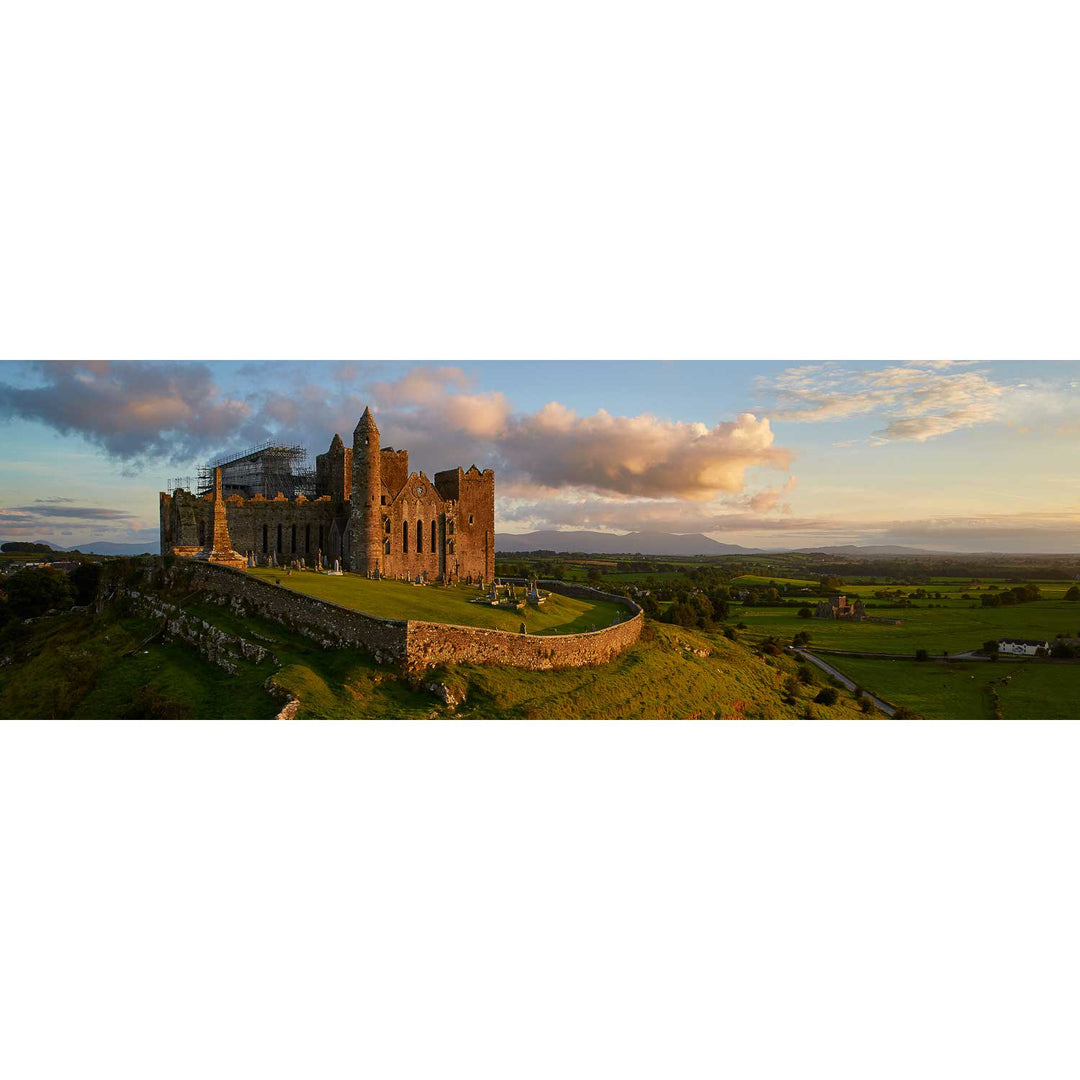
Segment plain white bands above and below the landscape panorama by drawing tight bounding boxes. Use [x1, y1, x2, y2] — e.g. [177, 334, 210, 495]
[0, 0, 1080, 1080]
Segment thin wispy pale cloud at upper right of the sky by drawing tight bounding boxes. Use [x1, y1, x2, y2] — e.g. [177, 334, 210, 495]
[756, 360, 1011, 436]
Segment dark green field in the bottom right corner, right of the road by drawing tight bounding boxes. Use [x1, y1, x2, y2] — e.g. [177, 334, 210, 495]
[823, 657, 1080, 720]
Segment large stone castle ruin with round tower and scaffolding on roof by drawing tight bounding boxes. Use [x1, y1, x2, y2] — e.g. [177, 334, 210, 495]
[159, 408, 495, 582]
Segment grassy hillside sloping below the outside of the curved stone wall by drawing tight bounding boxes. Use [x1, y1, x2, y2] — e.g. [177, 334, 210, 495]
[0, 597, 864, 718]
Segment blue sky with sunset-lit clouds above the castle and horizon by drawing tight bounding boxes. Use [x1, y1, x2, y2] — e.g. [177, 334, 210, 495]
[0, 361, 1080, 553]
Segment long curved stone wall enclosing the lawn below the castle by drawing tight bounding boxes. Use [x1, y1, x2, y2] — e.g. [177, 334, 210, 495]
[158, 559, 644, 674]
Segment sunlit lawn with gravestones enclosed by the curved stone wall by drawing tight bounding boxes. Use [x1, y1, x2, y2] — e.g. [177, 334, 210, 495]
[247, 567, 629, 634]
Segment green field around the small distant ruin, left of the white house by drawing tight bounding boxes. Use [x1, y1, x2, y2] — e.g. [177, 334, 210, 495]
[731, 599, 1080, 654]
